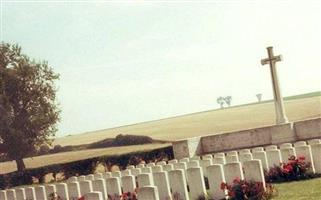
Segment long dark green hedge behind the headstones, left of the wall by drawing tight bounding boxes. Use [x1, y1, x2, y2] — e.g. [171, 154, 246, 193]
[0, 146, 174, 189]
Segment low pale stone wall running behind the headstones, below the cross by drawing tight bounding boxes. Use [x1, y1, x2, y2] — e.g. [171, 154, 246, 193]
[173, 118, 321, 158]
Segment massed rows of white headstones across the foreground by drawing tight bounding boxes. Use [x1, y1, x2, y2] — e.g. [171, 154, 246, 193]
[0, 140, 321, 200]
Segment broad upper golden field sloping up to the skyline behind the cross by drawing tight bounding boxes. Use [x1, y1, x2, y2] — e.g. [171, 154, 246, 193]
[54, 93, 321, 146]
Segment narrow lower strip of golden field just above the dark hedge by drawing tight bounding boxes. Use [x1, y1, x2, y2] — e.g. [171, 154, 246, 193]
[0, 143, 171, 174]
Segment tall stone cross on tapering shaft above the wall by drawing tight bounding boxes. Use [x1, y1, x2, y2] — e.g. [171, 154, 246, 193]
[261, 47, 288, 124]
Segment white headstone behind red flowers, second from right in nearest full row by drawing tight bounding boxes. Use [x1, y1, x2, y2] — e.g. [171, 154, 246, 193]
[223, 162, 244, 184]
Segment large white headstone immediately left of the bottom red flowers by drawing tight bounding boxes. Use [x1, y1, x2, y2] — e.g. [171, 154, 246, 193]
[206, 164, 226, 199]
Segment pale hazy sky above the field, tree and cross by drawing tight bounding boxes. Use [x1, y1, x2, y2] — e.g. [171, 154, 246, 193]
[0, 0, 321, 137]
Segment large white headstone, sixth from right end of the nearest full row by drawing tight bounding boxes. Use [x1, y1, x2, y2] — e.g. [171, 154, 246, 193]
[153, 172, 171, 200]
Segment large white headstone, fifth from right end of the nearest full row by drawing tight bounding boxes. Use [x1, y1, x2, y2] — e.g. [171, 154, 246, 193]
[168, 169, 189, 200]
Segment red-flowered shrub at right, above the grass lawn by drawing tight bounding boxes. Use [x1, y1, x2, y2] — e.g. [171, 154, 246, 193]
[265, 156, 316, 182]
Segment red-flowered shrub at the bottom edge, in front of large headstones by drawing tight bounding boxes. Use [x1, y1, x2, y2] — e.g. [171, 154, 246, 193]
[221, 178, 276, 200]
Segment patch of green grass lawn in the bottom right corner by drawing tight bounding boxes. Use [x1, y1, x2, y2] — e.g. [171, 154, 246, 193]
[273, 178, 321, 200]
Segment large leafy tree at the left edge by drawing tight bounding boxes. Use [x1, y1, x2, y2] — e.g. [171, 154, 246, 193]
[0, 43, 60, 171]
